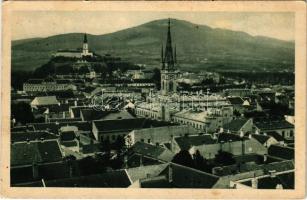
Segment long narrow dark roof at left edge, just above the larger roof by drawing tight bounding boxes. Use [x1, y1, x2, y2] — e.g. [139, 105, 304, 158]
[11, 131, 58, 143]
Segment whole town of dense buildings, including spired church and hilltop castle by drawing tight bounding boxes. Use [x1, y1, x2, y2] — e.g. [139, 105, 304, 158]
[11, 18, 295, 189]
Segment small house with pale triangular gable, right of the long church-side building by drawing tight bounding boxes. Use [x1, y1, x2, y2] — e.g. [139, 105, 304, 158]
[223, 118, 253, 135]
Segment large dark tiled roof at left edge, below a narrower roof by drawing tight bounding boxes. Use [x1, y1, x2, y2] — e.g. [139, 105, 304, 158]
[11, 141, 62, 166]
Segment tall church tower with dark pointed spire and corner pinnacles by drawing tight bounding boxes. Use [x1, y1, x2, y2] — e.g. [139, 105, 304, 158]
[161, 19, 178, 95]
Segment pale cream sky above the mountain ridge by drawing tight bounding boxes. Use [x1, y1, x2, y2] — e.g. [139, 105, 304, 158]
[12, 11, 295, 40]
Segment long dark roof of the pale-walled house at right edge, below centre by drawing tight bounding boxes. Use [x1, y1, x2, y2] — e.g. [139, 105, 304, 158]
[254, 120, 294, 131]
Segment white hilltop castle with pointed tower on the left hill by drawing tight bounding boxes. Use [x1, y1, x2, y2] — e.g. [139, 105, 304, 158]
[54, 33, 93, 58]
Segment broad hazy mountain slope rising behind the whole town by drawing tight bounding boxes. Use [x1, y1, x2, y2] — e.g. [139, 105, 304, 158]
[12, 19, 294, 71]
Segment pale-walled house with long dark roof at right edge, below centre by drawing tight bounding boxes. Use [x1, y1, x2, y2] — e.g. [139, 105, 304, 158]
[254, 120, 294, 139]
